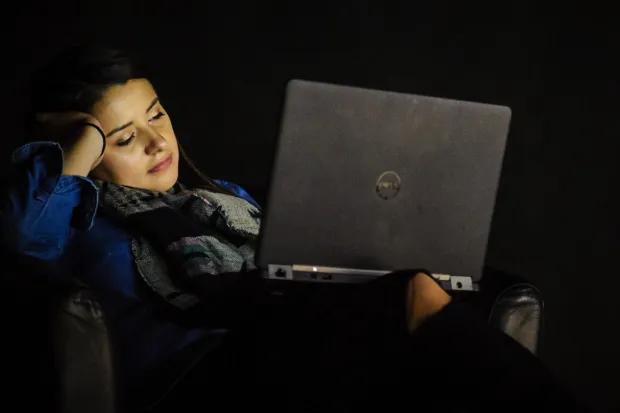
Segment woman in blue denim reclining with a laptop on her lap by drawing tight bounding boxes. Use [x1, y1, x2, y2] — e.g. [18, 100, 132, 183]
[0, 47, 588, 411]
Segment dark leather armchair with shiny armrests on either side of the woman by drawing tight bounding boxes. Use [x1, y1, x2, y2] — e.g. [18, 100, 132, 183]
[3, 271, 543, 413]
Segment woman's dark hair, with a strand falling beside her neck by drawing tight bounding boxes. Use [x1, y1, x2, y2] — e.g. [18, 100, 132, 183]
[26, 45, 234, 195]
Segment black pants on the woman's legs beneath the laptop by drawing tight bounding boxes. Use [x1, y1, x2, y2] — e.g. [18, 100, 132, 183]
[149, 270, 581, 412]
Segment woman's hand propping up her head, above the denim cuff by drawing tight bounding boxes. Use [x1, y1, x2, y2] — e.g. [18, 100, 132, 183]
[37, 112, 105, 176]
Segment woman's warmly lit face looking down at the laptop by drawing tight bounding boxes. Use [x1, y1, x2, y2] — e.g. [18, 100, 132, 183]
[92, 79, 179, 191]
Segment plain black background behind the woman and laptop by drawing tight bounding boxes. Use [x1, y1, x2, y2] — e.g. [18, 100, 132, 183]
[9, 0, 620, 411]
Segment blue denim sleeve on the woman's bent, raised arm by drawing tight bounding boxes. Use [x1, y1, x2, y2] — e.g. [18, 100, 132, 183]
[0, 142, 98, 261]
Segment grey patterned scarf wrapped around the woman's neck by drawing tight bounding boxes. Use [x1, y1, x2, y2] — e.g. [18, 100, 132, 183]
[97, 181, 261, 310]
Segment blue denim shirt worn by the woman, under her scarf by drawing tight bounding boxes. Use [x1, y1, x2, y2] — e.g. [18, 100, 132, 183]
[0, 142, 258, 392]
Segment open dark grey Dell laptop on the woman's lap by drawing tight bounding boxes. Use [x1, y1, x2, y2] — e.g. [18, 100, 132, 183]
[257, 80, 511, 290]
